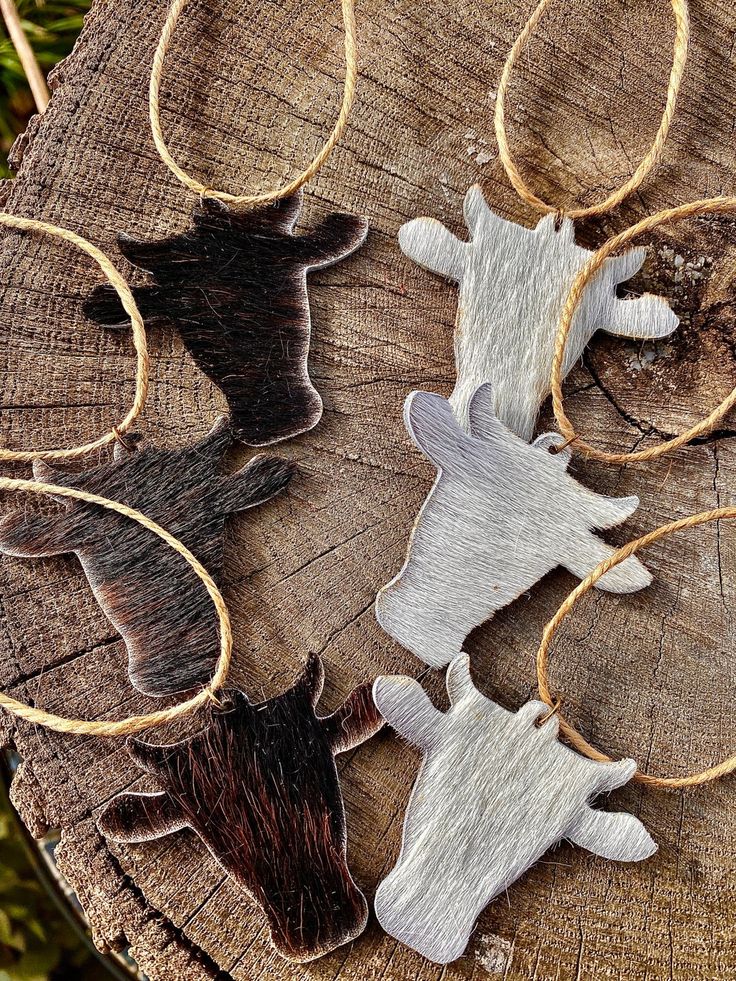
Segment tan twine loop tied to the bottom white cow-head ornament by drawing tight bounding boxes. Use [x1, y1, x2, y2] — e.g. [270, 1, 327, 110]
[537, 507, 736, 789]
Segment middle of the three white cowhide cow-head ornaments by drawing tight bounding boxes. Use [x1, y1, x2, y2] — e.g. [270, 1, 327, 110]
[376, 384, 651, 667]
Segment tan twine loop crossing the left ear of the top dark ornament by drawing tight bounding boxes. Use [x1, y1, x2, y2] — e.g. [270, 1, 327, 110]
[0, 212, 149, 463]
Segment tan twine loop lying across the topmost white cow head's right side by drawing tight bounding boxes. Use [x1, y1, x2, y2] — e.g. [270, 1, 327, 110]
[550, 198, 736, 463]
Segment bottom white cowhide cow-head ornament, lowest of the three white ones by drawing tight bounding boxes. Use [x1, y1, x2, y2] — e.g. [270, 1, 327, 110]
[373, 655, 657, 964]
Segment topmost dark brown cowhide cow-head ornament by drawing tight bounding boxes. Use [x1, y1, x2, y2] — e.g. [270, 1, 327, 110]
[85, 192, 368, 446]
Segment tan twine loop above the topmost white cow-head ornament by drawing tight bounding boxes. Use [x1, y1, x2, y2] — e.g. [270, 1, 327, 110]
[494, 0, 690, 218]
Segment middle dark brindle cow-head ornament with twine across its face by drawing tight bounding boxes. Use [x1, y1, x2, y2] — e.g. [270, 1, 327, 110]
[0, 419, 293, 697]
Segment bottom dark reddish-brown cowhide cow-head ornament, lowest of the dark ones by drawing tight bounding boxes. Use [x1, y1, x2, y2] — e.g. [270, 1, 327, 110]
[98, 655, 383, 961]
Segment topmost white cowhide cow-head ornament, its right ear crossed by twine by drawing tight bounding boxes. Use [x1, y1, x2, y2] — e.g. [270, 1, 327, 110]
[399, 185, 678, 440]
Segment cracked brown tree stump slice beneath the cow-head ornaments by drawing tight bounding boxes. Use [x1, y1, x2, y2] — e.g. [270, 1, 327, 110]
[0, 0, 736, 981]
